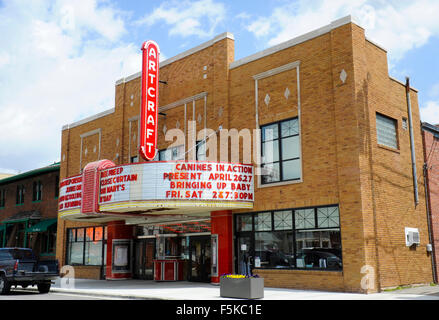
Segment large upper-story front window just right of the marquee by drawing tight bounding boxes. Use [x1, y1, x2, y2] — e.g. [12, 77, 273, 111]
[261, 118, 302, 184]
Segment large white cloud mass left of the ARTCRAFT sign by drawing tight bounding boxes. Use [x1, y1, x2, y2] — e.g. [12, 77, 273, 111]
[0, 0, 141, 171]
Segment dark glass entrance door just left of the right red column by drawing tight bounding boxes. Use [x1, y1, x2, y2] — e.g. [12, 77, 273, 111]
[188, 236, 212, 282]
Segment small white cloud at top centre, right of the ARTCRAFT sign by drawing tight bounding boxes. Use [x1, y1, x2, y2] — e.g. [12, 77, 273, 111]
[136, 0, 226, 38]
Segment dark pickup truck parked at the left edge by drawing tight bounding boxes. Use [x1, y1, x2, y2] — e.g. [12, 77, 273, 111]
[0, 248, 59, 294]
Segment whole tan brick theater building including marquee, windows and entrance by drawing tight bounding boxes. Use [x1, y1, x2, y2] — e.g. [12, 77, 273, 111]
[57, 16, 432, 293]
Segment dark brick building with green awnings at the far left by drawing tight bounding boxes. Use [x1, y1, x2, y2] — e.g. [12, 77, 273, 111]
[0, 163, 60, 258]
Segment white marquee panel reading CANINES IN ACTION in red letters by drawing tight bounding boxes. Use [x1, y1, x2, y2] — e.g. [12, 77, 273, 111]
[99, 161, 253, 205]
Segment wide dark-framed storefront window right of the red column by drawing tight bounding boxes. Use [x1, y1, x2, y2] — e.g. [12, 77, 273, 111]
[235, 206, 342, 271]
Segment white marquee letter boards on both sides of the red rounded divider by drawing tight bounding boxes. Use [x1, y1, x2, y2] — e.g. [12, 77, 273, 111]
[59, 161, 254, 216]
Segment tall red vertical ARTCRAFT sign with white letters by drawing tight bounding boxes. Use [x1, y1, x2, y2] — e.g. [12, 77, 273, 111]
[139, 40, 160, 160]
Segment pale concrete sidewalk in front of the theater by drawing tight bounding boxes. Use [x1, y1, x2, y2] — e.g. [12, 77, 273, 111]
[41, 279, 439, 300]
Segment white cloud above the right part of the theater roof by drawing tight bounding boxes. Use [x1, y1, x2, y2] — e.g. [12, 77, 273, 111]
[247, 0, 439, 61]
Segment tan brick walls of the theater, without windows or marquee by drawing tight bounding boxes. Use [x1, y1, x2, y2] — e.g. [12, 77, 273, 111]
[57, 18, 432, 292]
